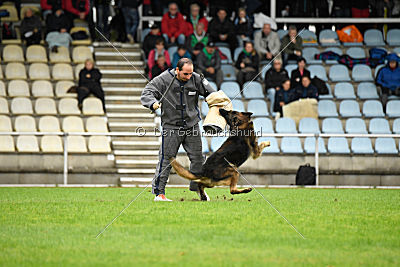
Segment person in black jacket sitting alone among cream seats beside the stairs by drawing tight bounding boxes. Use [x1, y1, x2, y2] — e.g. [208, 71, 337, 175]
[77, 59, 106, 112]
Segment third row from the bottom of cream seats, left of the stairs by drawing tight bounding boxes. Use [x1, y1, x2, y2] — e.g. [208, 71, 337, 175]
[0, 97, 104, 115]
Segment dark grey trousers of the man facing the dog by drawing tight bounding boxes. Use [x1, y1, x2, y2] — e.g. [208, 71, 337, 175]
[152, 124, 204, 195]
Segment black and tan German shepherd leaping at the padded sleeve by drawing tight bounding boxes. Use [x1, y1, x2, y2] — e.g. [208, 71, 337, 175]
[170, 109, 270, 201]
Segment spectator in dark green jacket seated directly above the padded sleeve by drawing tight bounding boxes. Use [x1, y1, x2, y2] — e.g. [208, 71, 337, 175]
[196, 42, 224, 87]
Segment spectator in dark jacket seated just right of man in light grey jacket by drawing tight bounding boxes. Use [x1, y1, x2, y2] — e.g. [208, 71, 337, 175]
[282, 25, 303, 65]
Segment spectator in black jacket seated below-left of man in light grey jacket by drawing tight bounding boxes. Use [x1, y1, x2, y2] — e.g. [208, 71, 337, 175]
[235, 41, 260, 86]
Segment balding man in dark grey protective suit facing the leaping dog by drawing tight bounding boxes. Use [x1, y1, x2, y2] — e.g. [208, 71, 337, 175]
[141, 58, 215, 201]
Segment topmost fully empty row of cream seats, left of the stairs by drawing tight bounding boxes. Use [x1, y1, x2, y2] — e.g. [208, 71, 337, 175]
[3, 45, 93, 64]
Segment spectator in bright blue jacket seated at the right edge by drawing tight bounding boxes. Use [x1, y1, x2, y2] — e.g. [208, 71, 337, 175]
[376, 53, 400, 113]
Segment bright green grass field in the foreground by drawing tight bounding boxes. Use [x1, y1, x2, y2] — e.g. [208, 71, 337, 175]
[0, 188, 400, 266]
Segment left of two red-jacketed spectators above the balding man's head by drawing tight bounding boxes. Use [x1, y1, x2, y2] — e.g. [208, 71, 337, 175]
[161, 2, 186, 44]
